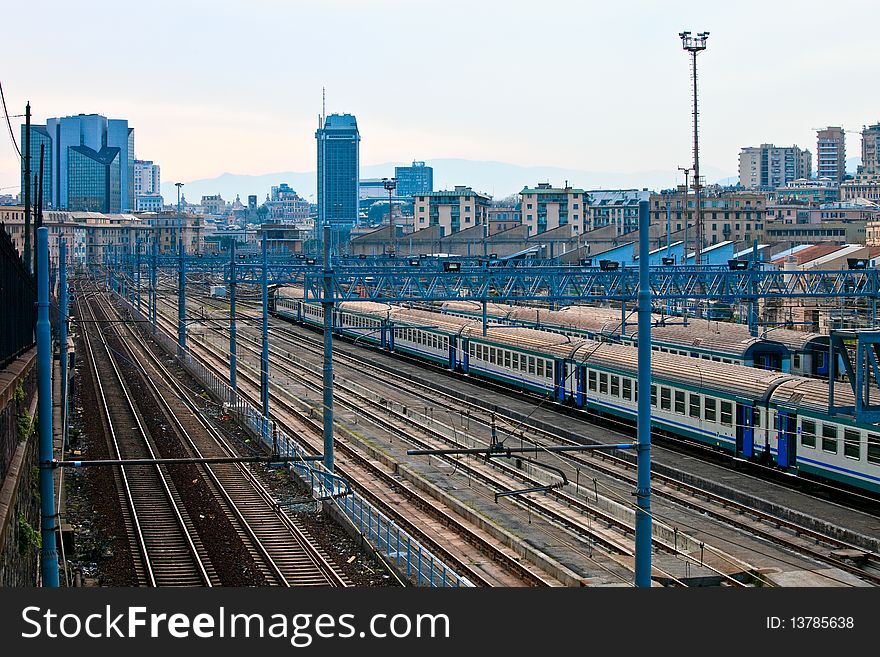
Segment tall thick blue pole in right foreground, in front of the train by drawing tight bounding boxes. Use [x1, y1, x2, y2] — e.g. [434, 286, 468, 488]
[635, 201, 652, 588]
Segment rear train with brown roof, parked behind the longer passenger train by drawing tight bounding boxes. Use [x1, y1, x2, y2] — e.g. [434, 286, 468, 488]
[437, 301, 843, 378]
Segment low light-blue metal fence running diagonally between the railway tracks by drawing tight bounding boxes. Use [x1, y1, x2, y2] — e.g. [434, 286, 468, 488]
[117, 295, 474, 587]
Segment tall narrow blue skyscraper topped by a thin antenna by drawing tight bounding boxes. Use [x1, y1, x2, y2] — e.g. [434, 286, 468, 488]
[315, 114, 361, 244]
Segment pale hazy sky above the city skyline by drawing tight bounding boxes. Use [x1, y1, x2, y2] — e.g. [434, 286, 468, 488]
[0, 0, 880, 192]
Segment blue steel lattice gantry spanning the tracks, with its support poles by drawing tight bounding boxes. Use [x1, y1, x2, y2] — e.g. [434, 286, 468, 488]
[108, 201, 880, 587]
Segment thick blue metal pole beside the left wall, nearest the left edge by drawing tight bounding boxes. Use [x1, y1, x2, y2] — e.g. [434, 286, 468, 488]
[37, 228, 58, 588]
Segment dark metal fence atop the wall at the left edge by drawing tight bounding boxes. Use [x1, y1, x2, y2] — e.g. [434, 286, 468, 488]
[0, 224, 37, 369]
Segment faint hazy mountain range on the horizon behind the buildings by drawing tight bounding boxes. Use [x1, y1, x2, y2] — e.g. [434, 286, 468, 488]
[162, 159, 737, 203]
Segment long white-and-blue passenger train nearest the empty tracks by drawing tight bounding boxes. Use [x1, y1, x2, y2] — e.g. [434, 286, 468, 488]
[271, 289, 880, 494]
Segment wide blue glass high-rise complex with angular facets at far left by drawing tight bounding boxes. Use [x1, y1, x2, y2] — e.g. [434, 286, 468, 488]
[22, 114, 135, 212]
